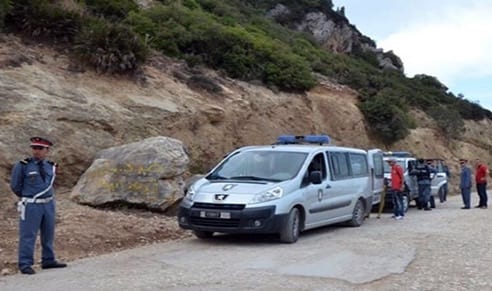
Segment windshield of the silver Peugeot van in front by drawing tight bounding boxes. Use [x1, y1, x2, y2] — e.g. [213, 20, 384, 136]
[207, 151, 307, 182]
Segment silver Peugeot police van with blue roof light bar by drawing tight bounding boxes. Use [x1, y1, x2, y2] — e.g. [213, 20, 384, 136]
[178, 135, 384, 243]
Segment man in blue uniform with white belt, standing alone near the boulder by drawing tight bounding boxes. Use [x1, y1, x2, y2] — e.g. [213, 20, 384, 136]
[10, 137, 67, 275]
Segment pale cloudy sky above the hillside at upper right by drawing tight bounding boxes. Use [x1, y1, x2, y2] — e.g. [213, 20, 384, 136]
[332, 0, 492, 111]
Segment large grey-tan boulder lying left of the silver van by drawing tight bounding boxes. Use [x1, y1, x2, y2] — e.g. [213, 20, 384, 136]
[71, 136, 189, 212]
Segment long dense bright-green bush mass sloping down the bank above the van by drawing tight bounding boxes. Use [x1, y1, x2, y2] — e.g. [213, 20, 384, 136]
[125, 1, 316, 90]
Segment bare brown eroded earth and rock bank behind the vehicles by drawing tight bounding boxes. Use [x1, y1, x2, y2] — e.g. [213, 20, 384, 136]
[0, 29, 492, 210]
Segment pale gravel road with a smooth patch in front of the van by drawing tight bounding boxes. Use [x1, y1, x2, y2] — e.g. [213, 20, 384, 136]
[0, 194, 492, 291]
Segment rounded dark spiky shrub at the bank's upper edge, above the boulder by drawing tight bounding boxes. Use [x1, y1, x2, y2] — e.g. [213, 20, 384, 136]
[75, 18, 147, 73]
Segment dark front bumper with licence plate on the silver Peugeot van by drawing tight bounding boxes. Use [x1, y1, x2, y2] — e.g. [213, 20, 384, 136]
[178, 203, 288, 233]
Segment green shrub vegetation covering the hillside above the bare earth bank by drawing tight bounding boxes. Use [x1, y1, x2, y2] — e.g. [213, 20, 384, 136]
[0, 0, 492, 145]
